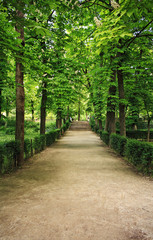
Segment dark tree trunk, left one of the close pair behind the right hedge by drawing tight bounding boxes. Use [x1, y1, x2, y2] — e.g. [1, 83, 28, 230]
[105, 70, 116, 135]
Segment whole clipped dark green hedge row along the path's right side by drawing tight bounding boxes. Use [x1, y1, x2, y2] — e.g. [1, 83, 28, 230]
[90, 119, 153, 175]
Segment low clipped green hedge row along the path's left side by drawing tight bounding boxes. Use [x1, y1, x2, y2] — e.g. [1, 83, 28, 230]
[0, 122, 70, 174]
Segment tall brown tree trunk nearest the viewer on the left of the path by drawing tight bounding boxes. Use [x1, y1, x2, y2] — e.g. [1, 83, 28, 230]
[15, 10, 24, 166]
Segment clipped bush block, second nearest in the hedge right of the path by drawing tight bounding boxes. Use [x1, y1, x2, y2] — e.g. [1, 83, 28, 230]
[110, 133, 127, 156]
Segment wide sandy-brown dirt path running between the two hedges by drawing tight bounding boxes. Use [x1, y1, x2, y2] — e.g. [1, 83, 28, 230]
[0, 131, 153, 240]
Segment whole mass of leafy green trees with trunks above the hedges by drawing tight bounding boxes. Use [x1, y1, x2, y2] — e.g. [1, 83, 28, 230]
[0, 0, 153, 172]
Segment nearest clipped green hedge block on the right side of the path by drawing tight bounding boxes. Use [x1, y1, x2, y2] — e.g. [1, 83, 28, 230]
[125, 139, 153, 173]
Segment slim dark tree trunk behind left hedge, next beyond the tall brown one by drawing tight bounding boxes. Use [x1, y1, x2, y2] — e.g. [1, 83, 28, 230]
[40, 81, 47, 134]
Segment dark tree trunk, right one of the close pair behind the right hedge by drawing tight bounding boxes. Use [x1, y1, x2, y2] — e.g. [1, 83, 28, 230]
[117, 64, 126, 136]
